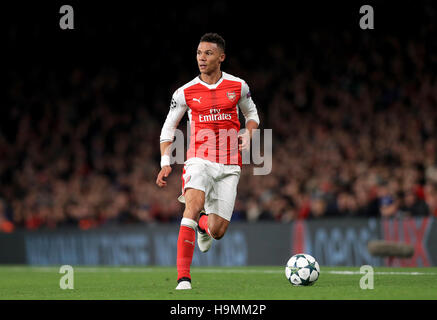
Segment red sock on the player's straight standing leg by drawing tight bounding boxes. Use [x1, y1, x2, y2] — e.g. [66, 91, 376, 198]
[176, 225, 196, 279]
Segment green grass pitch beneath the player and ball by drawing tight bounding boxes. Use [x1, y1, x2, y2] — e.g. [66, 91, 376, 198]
[0, 266, 437, 300]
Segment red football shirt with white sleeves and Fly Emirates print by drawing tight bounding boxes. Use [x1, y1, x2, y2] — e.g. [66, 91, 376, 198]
[160, 72, 259, 166]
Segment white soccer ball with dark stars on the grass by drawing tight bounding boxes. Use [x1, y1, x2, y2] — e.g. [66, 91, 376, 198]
[285, 253, 320, 286]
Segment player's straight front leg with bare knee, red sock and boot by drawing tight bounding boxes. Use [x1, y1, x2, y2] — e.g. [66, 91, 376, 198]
[176, 188, 205, 290]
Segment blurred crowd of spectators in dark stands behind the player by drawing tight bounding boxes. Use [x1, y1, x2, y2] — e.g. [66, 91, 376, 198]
[0, 4, 437, 232]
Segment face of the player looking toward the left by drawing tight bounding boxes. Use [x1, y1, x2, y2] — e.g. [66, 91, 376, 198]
[197, 42, 225, 74]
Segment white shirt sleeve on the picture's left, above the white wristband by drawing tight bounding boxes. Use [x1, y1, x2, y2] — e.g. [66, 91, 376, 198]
[159, 89, 188, 143]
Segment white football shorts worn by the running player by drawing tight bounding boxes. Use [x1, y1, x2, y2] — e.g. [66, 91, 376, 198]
[178, 158, 241, 221]
